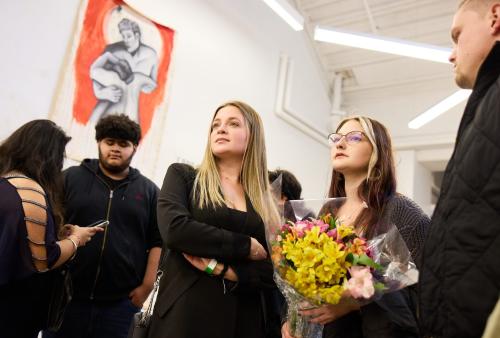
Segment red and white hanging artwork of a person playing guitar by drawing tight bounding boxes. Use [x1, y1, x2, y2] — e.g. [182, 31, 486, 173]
[49, 0, 174, 177]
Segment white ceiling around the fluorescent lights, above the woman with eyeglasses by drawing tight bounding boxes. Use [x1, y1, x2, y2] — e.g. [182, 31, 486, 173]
[292, 0, 463, 153]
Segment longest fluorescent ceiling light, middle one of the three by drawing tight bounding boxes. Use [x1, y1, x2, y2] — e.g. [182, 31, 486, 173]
[314, 26, 451, 63]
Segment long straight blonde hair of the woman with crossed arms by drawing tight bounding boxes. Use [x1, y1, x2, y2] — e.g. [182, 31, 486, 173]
[193, 101, 277, 227]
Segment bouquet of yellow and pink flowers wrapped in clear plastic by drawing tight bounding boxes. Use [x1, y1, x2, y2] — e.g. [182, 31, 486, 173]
[268, 199, 418, 338]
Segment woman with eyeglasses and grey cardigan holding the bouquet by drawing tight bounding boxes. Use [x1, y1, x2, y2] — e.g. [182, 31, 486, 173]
[282, 116, 430, 338]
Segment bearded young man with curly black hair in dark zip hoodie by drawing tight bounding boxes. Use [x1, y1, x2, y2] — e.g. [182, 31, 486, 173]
[47, 115, 161, 338]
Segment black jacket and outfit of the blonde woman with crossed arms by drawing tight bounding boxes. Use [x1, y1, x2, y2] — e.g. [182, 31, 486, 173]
[149, 164, 275, 338]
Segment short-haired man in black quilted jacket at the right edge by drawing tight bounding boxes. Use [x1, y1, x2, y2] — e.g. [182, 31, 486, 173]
[419, 0, 500, 337]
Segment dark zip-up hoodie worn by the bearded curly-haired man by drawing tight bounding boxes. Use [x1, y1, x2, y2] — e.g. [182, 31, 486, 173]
[64, 159, 162, 300]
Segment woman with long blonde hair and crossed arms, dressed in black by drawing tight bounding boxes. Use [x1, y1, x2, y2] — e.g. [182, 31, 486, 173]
[149, 101, 275, 338]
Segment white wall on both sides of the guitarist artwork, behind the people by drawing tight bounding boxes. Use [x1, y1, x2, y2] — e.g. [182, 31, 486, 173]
[0, 0, 336, 197]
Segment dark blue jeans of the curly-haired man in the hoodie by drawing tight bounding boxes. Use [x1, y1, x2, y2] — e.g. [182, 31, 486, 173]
[42, 298, 140, 338]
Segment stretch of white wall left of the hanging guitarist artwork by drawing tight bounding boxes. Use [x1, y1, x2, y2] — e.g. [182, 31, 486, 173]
[0, 0, 78, 140]
